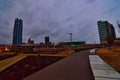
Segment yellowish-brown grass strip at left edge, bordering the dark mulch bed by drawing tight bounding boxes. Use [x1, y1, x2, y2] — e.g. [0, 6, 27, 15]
[0, 54, 27, 71]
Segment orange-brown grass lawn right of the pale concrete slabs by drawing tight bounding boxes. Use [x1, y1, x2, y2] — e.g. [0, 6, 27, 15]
[97, 47, 120, 73]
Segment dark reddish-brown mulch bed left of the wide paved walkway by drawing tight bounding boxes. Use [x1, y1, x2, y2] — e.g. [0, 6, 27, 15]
[0, 56, 63, 80]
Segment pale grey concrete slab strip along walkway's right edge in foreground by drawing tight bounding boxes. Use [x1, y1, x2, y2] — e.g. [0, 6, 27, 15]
[89, 55, 120, 80]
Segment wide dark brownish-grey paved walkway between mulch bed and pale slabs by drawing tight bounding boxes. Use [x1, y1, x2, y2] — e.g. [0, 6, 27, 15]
[24, 50, 94, 80]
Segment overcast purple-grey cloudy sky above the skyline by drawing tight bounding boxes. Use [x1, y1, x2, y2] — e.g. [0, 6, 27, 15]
[0, 0, 120, 44]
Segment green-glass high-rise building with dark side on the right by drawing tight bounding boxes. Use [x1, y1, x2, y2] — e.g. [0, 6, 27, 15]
[97, 21, 116, 44]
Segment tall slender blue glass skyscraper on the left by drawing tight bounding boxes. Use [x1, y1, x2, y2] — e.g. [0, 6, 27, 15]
[13, 18, 23, 45]
